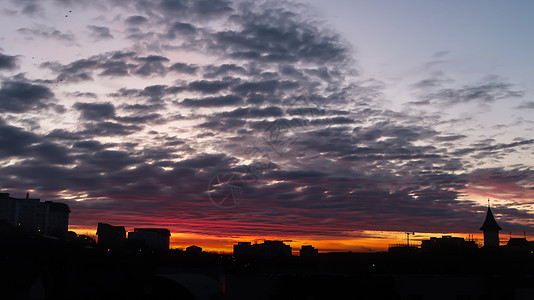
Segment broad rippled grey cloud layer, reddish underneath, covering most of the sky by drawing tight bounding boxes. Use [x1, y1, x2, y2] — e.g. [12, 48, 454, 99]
[0, 0, 534, 244]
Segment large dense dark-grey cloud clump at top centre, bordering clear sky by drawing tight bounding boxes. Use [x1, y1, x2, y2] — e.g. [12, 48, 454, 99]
[212, 5, 347, 63]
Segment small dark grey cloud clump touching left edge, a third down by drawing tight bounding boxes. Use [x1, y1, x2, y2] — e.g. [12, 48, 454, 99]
[0, 81, 54, 113]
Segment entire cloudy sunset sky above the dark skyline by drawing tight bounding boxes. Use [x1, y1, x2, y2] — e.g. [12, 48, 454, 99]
[0, 0, 534, 252]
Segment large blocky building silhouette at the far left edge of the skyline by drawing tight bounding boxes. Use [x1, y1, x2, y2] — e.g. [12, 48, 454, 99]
[0, 193, 70, 239]
